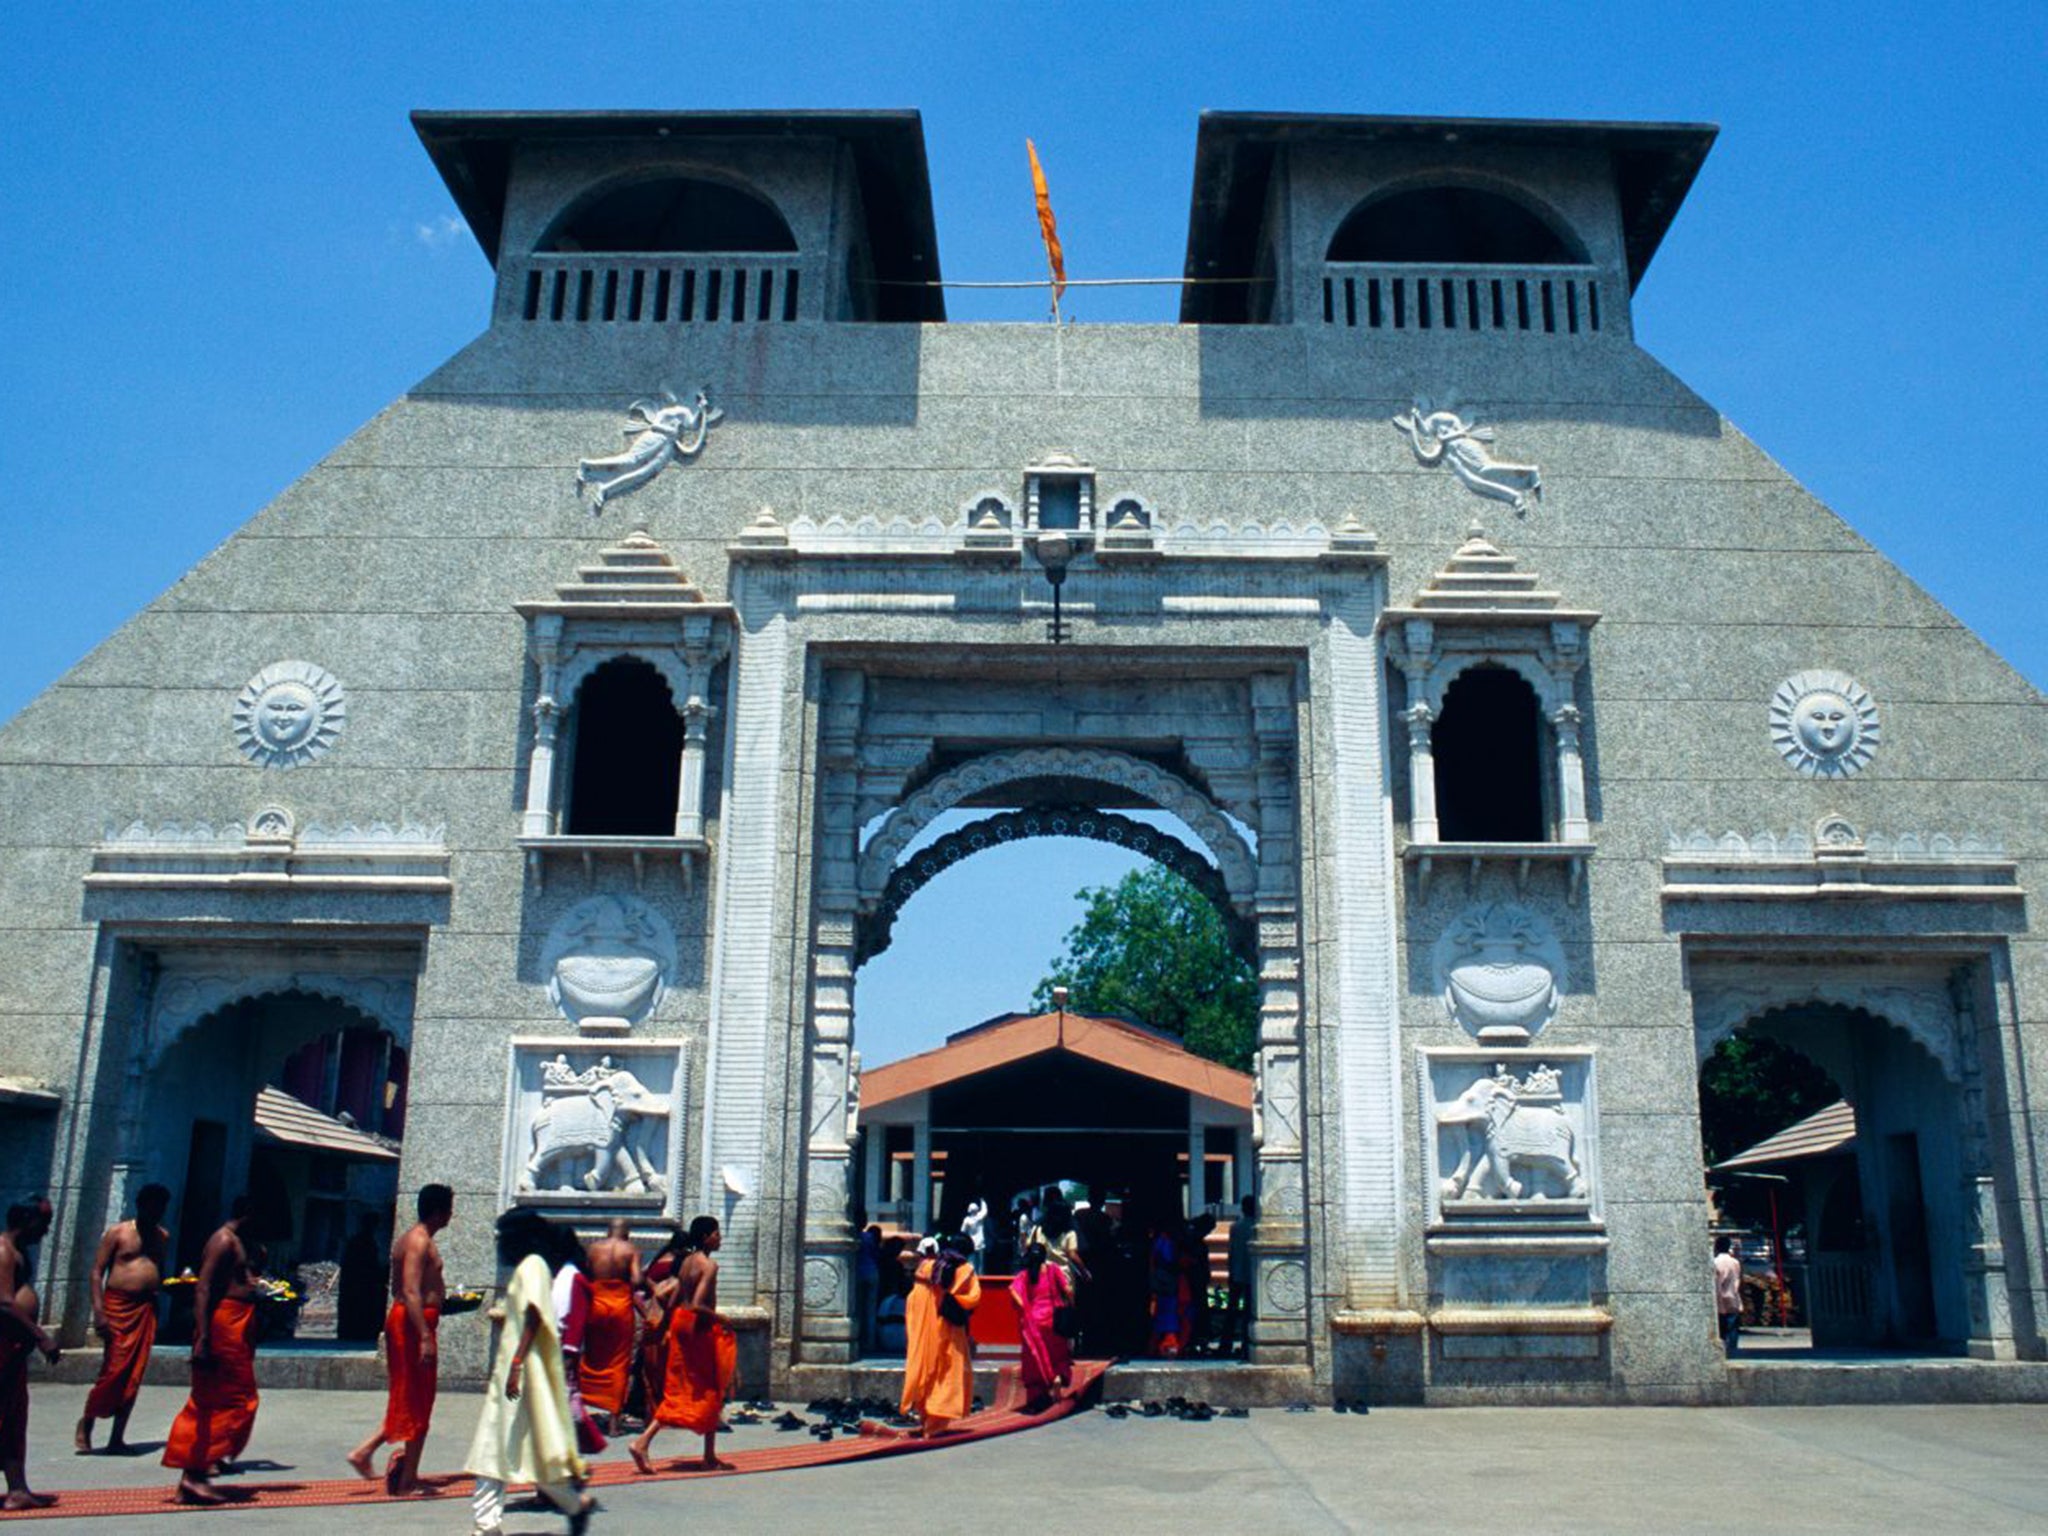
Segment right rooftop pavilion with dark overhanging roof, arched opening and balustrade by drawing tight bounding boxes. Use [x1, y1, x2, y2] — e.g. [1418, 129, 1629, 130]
[1180, 113, 1716, 338]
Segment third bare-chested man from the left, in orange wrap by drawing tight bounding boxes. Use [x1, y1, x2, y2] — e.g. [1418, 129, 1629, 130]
[164, 1194, 256, 1503]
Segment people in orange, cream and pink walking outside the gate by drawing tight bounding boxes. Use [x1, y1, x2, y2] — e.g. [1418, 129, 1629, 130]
[0, 1184, 1024, 1532]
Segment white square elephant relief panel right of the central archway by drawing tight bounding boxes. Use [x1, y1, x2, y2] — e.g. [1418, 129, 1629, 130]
[1417, 1049, 1597, 1221]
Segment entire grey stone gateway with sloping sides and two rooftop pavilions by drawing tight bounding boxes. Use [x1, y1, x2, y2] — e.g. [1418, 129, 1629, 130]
[0, 113, 2048, 1401]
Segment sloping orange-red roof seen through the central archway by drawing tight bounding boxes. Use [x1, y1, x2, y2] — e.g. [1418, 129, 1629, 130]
[860, 1014, 1251, 1114]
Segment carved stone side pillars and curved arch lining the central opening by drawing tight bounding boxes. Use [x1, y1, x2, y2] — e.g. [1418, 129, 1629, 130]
[797, 696, 1309, 1364]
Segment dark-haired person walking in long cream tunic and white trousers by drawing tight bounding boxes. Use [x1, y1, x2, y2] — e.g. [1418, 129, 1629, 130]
[465, 1208, 598, 1536]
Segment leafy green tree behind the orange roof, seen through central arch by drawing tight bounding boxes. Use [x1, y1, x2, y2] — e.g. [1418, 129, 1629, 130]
[1032, 864, 1260, 1071]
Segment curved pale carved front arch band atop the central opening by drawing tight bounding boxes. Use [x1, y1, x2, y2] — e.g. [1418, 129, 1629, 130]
[858, 748, 1257, 911]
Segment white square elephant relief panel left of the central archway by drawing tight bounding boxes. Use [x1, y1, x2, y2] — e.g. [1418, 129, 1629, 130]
[504, 1040, 688, 1214]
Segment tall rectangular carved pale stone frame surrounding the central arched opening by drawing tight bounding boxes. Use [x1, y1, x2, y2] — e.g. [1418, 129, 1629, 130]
[700, 518, 1403, 1378]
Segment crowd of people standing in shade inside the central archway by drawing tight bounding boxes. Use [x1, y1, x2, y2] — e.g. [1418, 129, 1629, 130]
[854, 1186, 1257, 1360]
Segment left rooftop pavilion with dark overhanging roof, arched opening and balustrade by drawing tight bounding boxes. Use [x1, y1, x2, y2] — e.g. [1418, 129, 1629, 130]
[412, 111, 946, 326]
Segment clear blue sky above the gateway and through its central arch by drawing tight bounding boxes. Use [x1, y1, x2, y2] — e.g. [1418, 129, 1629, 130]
[0, 0, 2048, 1059]
